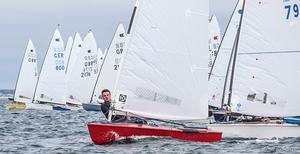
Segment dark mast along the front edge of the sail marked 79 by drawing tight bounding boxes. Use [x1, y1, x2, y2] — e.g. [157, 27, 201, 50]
[227, 0, 246, 106]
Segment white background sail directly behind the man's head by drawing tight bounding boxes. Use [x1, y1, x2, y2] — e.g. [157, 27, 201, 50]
[92, 24, 127, 102]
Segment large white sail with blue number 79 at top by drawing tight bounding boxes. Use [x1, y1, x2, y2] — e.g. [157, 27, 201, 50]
[231, 0, 300, 117]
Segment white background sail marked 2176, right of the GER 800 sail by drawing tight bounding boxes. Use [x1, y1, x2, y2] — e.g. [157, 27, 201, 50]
[67, 32, 100, 104]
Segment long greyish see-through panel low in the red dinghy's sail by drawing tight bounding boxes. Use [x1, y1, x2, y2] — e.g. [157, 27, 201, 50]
[136, 87, 181, 106]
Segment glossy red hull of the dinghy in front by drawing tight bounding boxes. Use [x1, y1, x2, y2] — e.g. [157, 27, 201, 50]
[88, 123, 222, 144]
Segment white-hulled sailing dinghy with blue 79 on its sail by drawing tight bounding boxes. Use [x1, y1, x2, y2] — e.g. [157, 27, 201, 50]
[209, 0, 300, 138]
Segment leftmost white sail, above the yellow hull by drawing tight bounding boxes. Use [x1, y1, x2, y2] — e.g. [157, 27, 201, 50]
[14, 40, 38, 103]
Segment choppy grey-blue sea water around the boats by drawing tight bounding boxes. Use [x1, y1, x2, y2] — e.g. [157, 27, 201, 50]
[0, 99, 300, 154]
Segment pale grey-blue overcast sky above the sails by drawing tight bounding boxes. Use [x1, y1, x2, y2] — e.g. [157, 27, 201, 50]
[0, 0, 236, 89]
